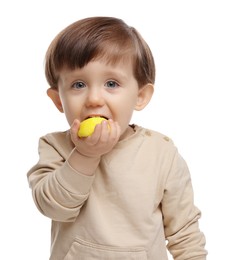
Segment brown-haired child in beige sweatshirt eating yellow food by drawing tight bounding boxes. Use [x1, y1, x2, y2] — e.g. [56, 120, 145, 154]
[28, 17, 206, 260]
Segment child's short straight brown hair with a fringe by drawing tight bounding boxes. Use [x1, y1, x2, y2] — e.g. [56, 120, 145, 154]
[45, 17, 155, 89]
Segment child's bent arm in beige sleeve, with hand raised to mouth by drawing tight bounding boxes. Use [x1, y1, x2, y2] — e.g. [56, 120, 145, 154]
[28, 119, 119, 222]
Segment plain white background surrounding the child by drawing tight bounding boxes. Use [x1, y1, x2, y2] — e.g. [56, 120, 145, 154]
[0, 0, 228, 260]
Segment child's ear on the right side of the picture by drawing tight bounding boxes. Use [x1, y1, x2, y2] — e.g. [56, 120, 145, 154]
[135, 83, 154, 111]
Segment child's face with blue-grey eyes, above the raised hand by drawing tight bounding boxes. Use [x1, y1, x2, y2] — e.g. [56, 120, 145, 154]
[49, 61, 151, 139]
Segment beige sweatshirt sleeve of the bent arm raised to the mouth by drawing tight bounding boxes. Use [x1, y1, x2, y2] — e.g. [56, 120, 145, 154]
[27, 135, 94, 222]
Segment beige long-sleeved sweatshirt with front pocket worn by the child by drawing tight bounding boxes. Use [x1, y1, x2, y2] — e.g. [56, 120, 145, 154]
[28, 127, 206, 260]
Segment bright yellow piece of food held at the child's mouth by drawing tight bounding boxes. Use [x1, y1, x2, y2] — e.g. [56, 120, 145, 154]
[78, 116, 107, 137]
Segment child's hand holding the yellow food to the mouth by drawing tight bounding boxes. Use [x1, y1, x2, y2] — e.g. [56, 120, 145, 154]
[70, 119, 120, 157]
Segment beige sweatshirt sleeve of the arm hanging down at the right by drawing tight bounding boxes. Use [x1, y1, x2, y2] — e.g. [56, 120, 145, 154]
[162, 152, 207, 260]
